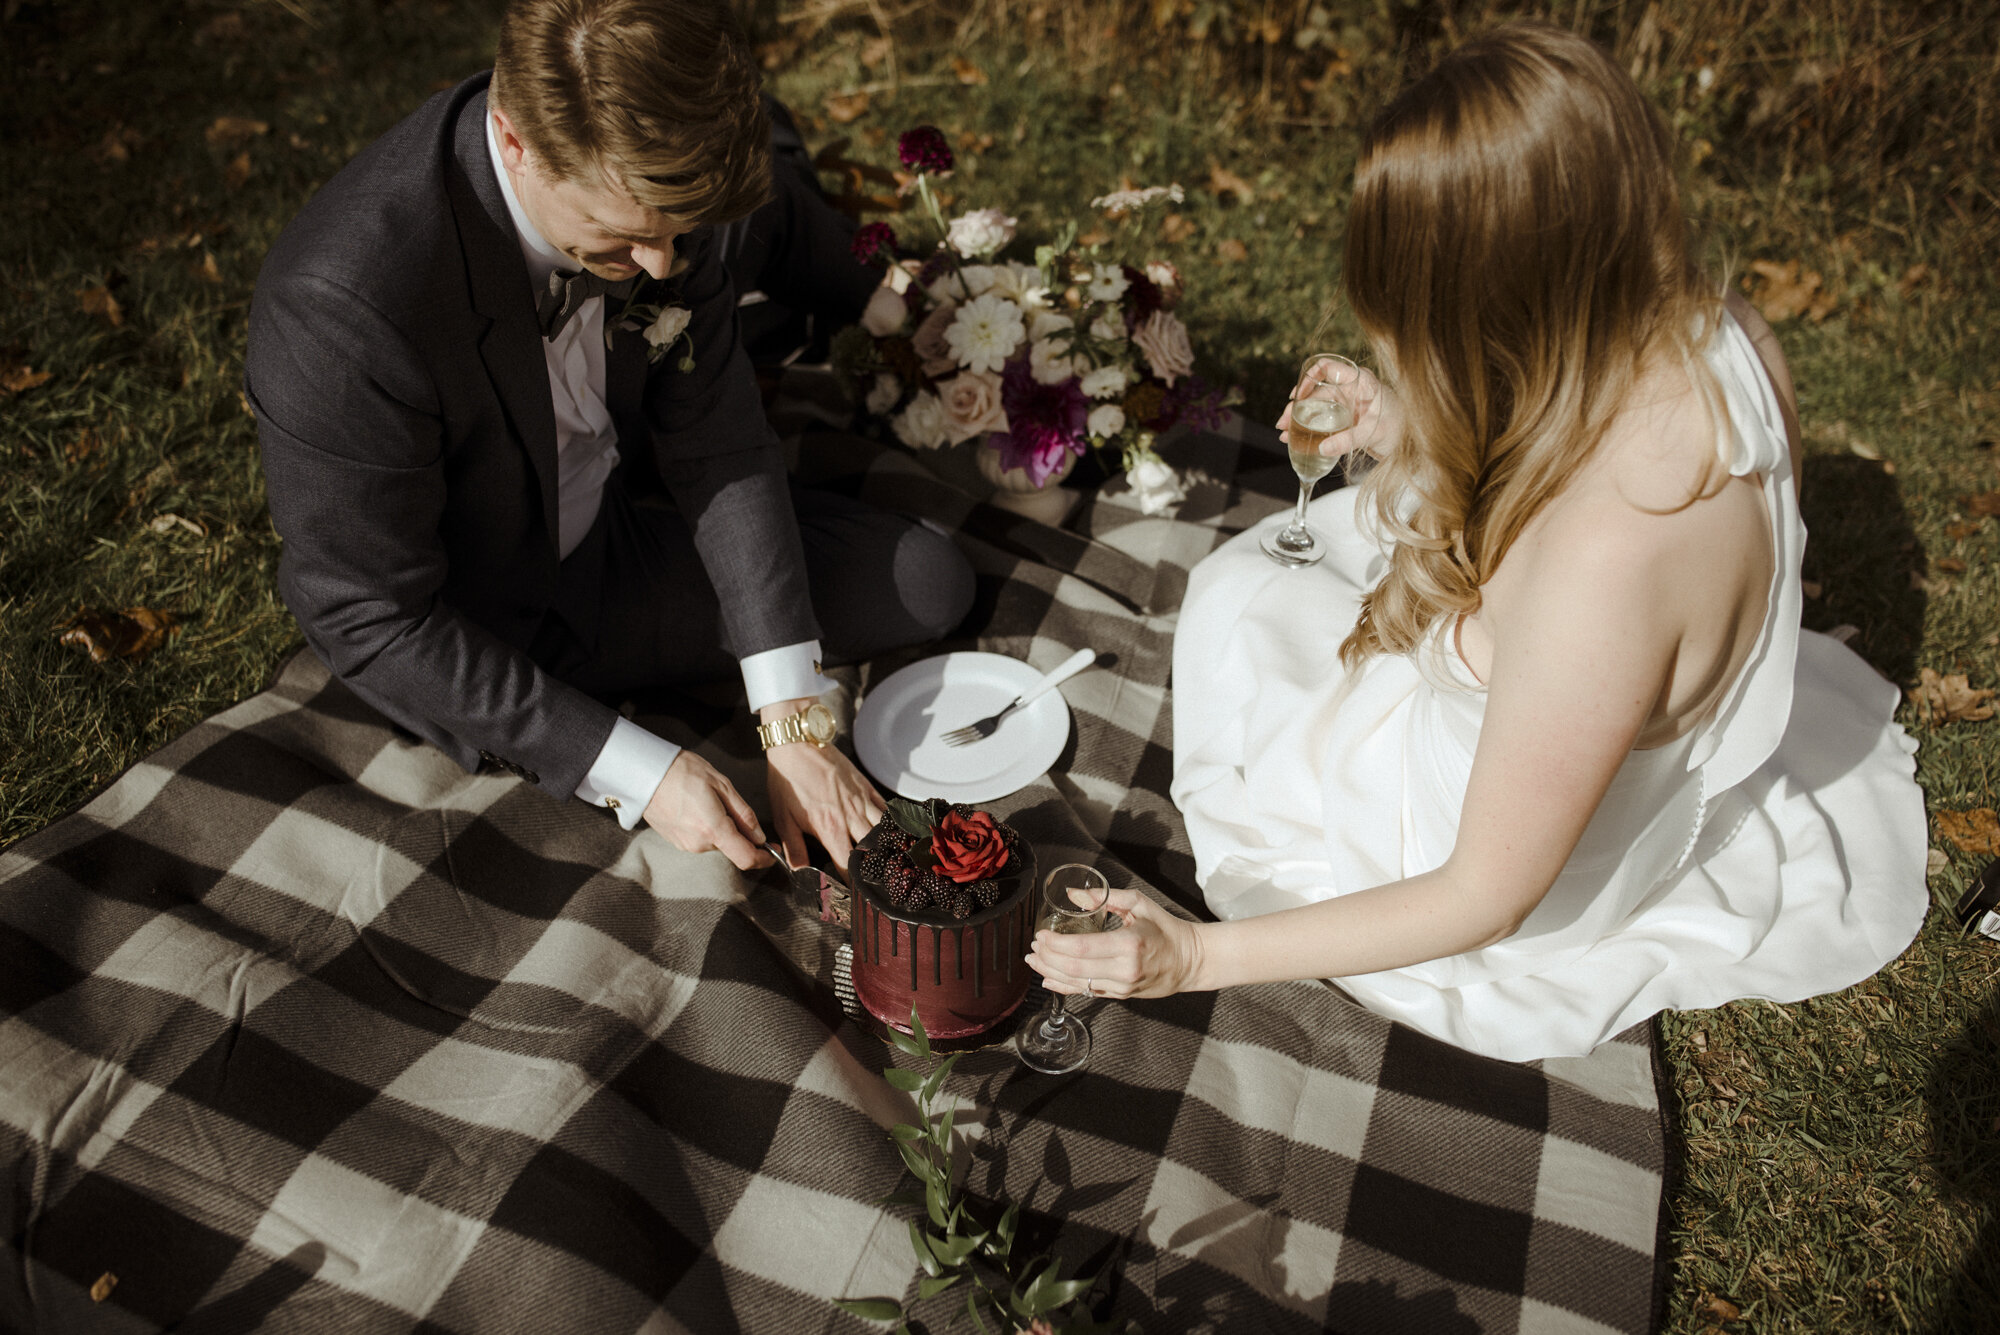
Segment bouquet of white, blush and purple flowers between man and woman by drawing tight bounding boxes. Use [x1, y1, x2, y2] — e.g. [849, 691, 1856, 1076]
[834, 126, 1224, 514]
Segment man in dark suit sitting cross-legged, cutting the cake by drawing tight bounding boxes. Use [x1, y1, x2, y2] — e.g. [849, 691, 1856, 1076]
[244, 0, 972, 869]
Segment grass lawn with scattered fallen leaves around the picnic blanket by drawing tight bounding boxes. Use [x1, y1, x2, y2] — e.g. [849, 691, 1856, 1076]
[0, 0, 2000, 1333]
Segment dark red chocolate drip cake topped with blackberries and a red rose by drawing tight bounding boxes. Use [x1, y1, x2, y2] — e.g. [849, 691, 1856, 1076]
[852, 797, 1034, 1039]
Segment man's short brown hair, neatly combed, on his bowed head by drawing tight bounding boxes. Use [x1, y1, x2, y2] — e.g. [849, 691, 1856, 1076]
[492, 0, 770, 224]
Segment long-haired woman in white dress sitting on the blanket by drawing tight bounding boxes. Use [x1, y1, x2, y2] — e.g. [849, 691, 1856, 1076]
[1030, 24, 1928, 1059]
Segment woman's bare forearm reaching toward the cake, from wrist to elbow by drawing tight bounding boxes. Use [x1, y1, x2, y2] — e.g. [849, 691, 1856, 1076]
[1186, 867, 1540, 991]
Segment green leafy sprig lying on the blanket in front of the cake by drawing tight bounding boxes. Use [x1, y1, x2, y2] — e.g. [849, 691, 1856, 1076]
[834, 1007, 1126, 1335]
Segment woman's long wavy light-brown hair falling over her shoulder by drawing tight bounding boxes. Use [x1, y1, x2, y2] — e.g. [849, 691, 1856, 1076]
[1340, 22, 1720, 668]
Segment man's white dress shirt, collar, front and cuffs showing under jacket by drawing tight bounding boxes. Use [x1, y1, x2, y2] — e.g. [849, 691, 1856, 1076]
[486, 114, 832, 829]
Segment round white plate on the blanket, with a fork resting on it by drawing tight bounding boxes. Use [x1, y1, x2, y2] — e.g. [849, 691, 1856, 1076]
[854, 654, 1070, 801]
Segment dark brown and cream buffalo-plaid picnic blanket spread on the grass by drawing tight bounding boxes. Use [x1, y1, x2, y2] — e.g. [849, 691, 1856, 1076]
[0, 424, 1664, 1335]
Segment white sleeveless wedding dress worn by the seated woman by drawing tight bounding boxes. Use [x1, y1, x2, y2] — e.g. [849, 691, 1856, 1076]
[1172, 318, 1930, 1061]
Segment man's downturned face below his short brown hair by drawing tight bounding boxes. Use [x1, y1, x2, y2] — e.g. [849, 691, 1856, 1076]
[492, 108, 694, 282]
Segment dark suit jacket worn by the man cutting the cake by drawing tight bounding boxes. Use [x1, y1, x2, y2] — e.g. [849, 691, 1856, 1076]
[244, 74, 820, 797]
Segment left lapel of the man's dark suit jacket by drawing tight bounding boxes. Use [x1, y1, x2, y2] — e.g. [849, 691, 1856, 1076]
[446, 81, 560, 550]
